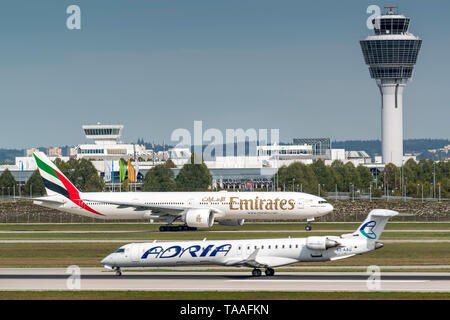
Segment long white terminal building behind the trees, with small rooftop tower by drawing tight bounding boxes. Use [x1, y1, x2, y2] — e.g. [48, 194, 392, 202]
[0, 123, 384, 190]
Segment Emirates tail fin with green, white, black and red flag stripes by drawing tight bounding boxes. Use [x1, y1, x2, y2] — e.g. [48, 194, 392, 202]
[33, 152, 103, 215]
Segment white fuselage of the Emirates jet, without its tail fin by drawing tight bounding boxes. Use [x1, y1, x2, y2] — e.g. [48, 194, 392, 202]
[34, 192, 333, 221]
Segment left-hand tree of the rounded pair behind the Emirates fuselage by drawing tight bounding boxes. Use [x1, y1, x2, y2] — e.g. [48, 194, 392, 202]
[142, 162, 176, 191]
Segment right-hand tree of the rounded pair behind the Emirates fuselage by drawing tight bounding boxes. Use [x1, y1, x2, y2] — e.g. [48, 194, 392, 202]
[175, 154, 212, 191]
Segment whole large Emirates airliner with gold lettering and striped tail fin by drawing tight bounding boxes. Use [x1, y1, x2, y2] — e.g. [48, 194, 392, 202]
[34, 152, 333, 231]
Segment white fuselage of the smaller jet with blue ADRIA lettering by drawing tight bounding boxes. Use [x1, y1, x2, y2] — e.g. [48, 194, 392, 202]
[101, 236, 375, 268]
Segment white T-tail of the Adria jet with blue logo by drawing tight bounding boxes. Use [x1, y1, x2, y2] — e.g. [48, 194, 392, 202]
[352, 209, 398, 241]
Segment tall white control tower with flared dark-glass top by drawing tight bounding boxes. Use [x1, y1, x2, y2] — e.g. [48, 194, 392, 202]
[360, 7, 422, 166]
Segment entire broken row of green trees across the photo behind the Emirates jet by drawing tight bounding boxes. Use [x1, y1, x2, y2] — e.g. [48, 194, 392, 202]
[0, 155, 450, 198]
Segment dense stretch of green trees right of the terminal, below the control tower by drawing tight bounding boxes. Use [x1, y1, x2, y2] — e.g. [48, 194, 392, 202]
[273, 159, 450, 198]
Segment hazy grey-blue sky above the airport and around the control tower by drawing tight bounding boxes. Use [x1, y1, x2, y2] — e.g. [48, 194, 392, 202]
[0, 0, 450, 148]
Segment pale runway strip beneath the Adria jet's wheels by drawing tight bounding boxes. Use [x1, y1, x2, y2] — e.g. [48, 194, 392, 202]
[0, 268, 450, 292]
